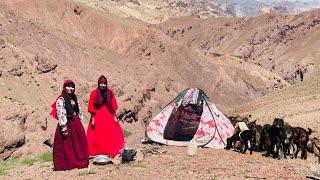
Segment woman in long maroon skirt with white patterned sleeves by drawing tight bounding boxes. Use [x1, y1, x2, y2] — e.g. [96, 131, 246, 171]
[51, 80, 89, 171]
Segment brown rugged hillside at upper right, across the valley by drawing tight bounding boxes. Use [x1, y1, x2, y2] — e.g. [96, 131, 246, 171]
[158, 11, 320, 83]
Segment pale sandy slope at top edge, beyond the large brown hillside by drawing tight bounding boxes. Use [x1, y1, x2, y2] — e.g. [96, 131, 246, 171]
[75, 0, 232, 24]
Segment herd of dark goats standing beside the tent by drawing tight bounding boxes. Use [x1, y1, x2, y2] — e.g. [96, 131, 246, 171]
[226, 116, 320, 163]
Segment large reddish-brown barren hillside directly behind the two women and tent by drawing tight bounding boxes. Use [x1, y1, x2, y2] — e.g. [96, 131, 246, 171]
[0, 0, 288, 159]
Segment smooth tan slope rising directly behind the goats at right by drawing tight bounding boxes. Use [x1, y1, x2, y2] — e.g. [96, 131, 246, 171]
[232, 79, 320, 136]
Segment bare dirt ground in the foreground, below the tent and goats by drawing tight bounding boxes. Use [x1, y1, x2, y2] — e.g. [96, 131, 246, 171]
[2, 141, 316, 179]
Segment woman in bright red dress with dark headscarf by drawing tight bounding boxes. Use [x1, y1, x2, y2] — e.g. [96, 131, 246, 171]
[87, 75, 125, 157]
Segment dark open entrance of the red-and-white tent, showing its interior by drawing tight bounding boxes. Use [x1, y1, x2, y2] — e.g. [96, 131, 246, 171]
[163, 101, 203, 141]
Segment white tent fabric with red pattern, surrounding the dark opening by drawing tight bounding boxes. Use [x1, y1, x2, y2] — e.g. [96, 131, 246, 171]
[146, 88, 234, 149]
